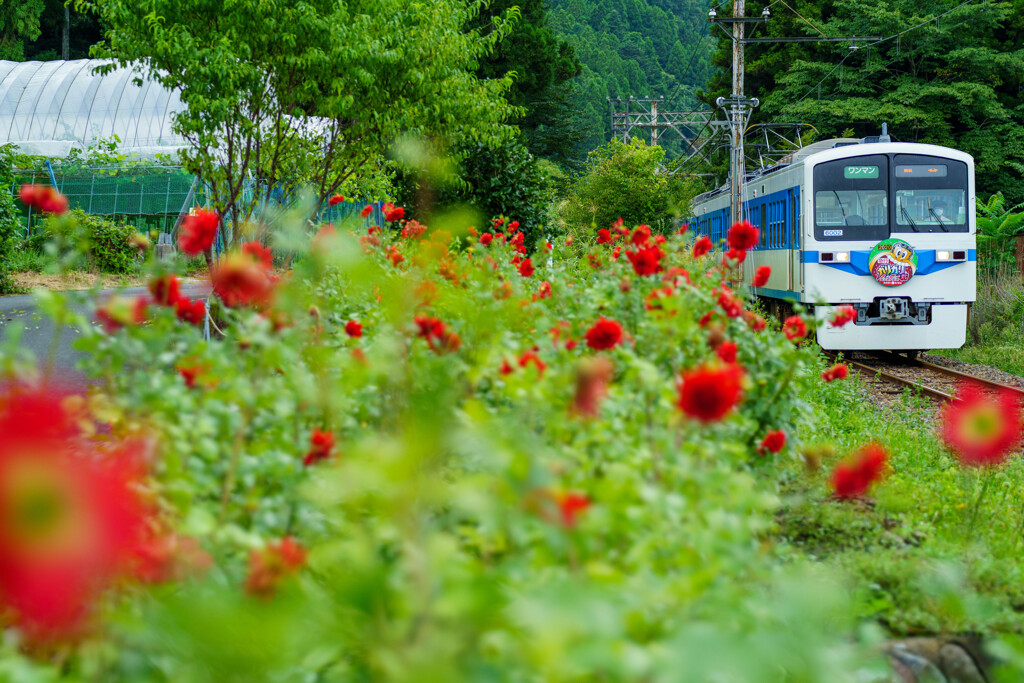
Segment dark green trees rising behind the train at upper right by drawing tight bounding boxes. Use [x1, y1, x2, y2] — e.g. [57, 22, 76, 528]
[703, 0, 1024, 203]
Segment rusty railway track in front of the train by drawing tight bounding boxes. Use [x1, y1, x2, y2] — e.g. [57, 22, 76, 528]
[829, 351, 1024, 401]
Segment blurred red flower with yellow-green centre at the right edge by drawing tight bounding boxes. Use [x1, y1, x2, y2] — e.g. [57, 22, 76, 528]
[940, 383, 1021, 466]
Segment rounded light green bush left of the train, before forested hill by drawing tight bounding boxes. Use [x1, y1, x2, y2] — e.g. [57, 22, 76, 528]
[561, 138, 696, 232]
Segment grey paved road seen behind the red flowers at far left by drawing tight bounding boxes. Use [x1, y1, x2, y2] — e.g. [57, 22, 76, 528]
[0, 283, 209, 389]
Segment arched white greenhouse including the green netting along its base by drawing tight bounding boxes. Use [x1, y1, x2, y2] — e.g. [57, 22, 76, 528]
[0, 59, 198, 237]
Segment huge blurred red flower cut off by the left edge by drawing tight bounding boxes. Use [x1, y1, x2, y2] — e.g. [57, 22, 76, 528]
[0, 388, 151, 643]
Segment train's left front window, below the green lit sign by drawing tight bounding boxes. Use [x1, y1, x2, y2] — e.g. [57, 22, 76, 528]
[814, 155, 890, 241]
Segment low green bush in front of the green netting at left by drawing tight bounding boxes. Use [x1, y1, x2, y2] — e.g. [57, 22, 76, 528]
[43, 209, 139, 274]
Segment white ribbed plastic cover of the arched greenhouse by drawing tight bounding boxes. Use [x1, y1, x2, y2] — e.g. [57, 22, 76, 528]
[0, 59, 187, 157]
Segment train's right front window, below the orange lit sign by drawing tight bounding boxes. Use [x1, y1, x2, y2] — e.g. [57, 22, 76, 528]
[893, 155, 970, 232]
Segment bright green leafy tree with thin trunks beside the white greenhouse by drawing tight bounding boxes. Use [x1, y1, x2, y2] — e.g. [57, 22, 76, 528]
[76, 0, 513, 252]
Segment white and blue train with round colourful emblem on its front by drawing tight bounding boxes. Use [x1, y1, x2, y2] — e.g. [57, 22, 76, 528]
[692, 135, 977, 352]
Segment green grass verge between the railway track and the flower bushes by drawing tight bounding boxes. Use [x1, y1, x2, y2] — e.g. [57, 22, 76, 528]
[776, 356, 1024, 636]
